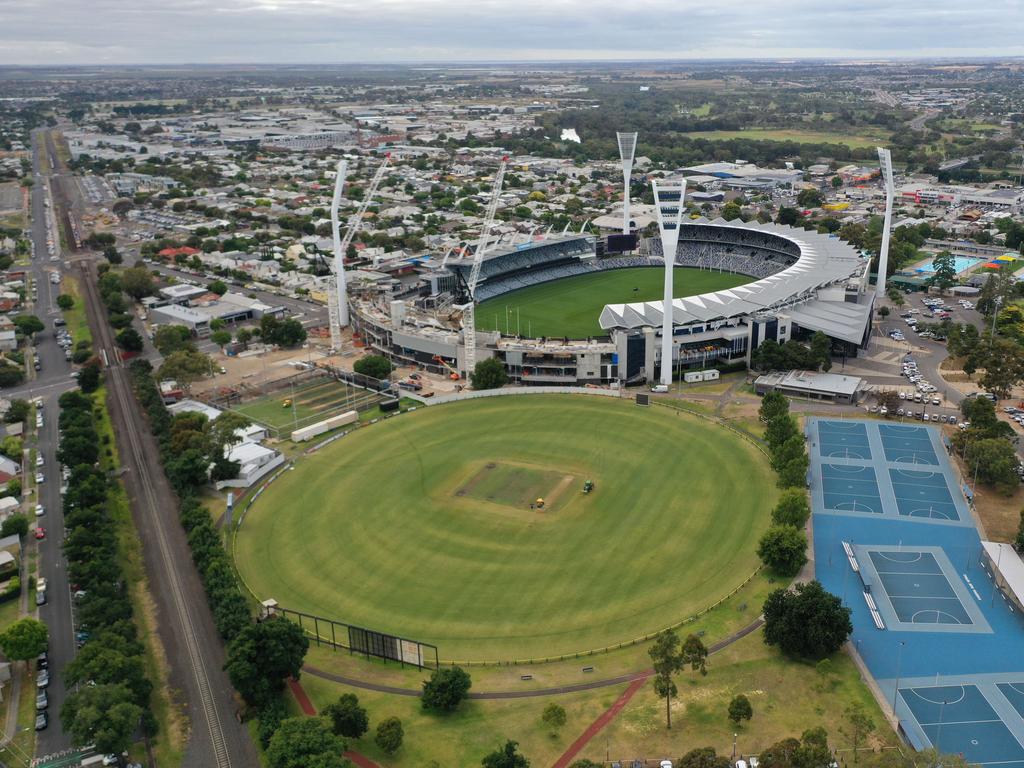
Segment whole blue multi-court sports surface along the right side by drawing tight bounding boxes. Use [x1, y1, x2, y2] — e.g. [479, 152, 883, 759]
[806, 419, 1024, 768]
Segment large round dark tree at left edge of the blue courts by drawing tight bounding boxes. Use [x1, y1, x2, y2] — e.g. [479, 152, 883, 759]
[762, 581, 853, 659]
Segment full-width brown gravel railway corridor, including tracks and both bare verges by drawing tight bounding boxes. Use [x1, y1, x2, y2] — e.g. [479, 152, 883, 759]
[80, 262, 259, 768]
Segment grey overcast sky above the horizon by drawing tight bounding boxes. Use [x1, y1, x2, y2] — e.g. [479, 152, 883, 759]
[0, 0, 1024, 65]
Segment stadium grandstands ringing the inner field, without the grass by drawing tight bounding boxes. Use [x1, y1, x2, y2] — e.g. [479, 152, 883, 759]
[355, 219, 872, 385]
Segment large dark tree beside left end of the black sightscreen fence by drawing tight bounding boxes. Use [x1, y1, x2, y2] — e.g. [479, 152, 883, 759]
[224, 618, 309, 707]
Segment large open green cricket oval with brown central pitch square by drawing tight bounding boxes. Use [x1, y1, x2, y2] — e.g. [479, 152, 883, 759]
[234, 395, 775, 660]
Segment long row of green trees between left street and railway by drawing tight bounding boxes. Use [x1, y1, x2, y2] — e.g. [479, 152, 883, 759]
[57, 391, 157, 755]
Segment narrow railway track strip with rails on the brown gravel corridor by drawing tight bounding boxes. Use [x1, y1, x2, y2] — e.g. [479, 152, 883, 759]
[80, 263, 231, 768]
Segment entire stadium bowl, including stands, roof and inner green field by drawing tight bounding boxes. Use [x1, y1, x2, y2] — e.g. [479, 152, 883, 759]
[352, 219, 872, 386]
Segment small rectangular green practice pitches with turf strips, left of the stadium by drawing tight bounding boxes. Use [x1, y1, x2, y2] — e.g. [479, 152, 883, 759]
[233, 377, 380, 432]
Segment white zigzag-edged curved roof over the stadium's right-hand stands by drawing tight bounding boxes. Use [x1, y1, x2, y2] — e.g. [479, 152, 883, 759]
[600, 219, 866, 330]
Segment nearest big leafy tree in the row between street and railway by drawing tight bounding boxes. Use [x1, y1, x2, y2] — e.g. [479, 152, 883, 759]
[59, 684, 142, 755]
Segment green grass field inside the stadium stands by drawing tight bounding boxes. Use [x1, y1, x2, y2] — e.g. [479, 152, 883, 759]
[476, 267, 753, 339]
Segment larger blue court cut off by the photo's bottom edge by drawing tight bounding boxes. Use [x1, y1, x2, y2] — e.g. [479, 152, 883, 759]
[899, 685, 1024, 768]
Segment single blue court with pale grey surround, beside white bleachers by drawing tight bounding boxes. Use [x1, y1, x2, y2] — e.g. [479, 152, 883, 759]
[869, 551, 974, 625]
